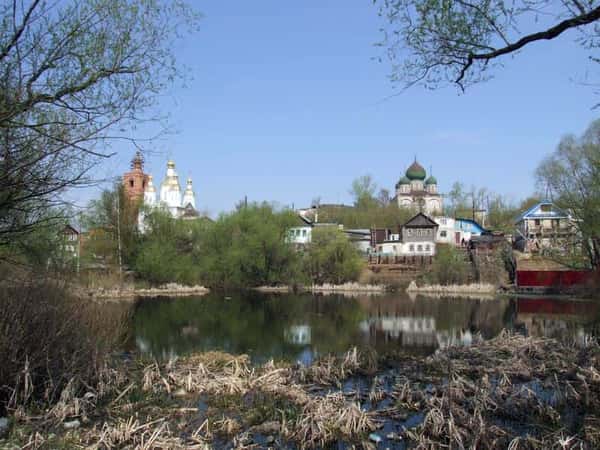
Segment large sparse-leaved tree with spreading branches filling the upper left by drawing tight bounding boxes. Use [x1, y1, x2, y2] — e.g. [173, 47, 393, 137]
[0, 0, 196, 253]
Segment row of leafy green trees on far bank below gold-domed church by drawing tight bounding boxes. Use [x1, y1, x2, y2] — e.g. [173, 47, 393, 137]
[83, 198, 364, 289]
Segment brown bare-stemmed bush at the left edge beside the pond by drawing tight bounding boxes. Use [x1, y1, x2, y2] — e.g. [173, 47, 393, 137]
[0, 268, 124, 411]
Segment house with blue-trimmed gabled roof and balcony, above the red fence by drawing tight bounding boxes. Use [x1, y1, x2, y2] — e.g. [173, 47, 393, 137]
[515, 201, 577, 252]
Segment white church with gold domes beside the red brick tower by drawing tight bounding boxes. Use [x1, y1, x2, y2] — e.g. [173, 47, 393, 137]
[144, 160, 198, 218]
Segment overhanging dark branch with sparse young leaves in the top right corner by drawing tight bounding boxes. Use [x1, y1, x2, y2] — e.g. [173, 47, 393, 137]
[375, 0, 600, 90]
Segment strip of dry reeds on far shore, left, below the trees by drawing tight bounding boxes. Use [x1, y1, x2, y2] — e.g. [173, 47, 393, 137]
[75, 283, 210, 300]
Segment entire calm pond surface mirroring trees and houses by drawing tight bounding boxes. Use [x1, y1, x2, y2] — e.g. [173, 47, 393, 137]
[131, 292, 598, 363]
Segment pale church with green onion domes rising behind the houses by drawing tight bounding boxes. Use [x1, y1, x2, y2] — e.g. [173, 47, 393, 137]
[396, 159, 444, 215]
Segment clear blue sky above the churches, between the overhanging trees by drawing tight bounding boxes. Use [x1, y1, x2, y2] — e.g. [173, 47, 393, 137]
[90, 0, 598, 215]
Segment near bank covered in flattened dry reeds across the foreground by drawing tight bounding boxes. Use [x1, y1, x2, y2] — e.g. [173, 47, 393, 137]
[0, 333, 600, 449]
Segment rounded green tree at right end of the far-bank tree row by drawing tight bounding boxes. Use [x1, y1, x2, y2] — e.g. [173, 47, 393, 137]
[307, 227, 364, 284]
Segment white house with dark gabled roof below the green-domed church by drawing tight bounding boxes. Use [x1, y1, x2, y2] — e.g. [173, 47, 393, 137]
[372, 213, 439, 256]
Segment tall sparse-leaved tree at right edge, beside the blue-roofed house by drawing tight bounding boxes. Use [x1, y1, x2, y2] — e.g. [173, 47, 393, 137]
[536, 120, 600, 267]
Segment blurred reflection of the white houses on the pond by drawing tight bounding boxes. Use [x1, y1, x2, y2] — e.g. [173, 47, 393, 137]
[360, 316, 473, 348]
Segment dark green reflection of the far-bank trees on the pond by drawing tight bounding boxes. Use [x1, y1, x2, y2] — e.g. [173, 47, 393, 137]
[134, 292, 363, 359]
